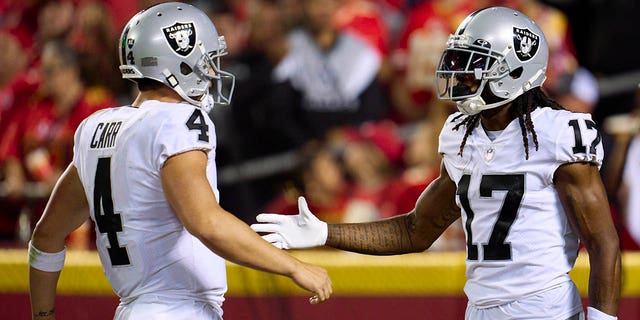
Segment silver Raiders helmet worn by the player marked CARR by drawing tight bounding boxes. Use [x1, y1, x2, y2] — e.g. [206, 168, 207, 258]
[119, 2, 235, 111]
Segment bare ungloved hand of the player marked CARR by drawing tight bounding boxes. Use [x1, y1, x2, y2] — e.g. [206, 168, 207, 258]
[291, 262, 333, 304]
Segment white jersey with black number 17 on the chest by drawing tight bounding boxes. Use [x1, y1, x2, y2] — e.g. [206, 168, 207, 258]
[439, 108, 603, 307]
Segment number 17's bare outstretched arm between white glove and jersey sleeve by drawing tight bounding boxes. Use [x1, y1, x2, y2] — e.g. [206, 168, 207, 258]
[326, 160, 460, 255]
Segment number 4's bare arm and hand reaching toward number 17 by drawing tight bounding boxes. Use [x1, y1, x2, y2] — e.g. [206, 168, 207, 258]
[161, 150, 332, 303]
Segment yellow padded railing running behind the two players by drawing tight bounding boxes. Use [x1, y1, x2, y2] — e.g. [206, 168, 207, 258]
[0, 249, 640, 297]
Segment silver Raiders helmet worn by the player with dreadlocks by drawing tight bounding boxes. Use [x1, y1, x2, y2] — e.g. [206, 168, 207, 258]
[436, 7, 549, 115]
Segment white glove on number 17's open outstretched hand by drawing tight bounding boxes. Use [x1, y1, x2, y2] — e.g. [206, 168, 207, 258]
[251, 197, 327, 249]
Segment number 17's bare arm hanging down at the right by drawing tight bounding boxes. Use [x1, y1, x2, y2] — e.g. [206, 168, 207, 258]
[555, 163, 621, 315]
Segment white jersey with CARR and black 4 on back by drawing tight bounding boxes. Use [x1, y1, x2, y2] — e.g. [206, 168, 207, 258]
[73, 101, 227, 314]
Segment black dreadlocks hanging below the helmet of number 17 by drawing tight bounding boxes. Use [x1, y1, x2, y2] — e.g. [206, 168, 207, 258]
[453, 87, 565, 160]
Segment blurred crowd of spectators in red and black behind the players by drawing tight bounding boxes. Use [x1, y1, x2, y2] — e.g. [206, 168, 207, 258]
[0, 0, 640, 250]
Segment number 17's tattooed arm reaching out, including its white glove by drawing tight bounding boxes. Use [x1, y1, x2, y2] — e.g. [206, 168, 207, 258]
[251, 160, 460, 255]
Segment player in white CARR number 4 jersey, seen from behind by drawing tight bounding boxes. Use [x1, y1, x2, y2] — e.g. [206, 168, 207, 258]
[29, 2, 332, 319]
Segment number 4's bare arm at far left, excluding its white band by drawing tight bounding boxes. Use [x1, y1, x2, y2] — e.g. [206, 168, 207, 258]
[29, 165, 89, 320]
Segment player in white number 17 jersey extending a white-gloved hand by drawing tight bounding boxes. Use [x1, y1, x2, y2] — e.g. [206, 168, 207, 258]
[252, 7, 621, 320]
